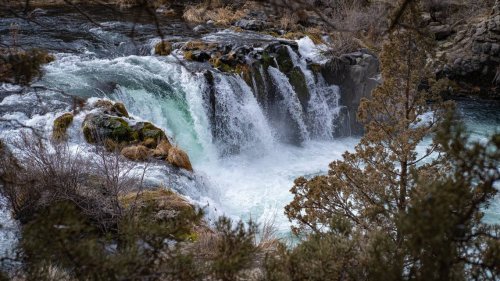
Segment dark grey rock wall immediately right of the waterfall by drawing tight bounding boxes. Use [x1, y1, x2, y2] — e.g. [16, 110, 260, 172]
[321, 51, 380, 136]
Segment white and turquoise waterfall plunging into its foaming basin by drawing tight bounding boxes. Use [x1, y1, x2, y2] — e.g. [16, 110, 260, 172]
[11, 43, 355, 234]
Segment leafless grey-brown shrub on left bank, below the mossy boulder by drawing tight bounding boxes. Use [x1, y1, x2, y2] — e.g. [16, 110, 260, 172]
[0, 132, 148, 230]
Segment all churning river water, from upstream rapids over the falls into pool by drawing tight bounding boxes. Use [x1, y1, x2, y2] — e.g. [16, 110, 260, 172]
[0, 8, 500, 247]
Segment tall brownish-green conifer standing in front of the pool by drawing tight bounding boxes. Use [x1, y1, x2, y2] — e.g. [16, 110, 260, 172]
[286, 1, 446, 238]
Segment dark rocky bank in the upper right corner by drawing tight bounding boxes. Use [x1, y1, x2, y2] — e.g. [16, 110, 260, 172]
[439, 0, 500, 98]
